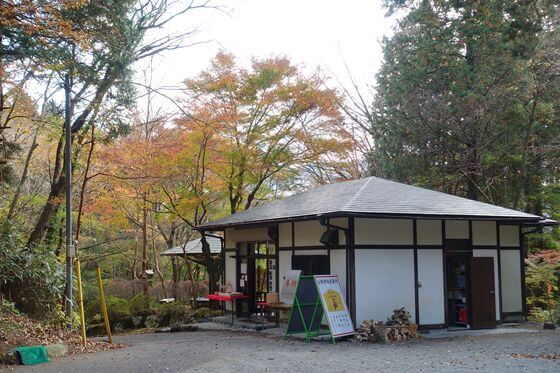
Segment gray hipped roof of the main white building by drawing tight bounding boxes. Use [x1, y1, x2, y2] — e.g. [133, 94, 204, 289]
[200, 177, 540, 229]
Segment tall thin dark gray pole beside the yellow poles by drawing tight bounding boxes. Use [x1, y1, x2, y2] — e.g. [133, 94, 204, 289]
[64, 74, 75, 329]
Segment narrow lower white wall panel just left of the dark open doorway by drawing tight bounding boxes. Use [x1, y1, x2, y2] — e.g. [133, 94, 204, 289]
[418, 249, 445, 325]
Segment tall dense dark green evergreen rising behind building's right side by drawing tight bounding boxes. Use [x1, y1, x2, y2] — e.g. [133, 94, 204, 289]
[372, 0, 560, 215]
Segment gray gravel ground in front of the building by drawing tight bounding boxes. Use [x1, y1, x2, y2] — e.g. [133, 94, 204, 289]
[2, 330, 560, 373]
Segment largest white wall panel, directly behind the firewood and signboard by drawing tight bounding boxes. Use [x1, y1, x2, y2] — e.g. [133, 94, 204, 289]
[356, 249, 415, 325]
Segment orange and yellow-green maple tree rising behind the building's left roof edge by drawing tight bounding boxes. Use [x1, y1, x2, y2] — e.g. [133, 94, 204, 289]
[179, 52, 352, 214]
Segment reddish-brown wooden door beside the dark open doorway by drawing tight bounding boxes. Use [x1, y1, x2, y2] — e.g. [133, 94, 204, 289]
[470, 257, 496, 329]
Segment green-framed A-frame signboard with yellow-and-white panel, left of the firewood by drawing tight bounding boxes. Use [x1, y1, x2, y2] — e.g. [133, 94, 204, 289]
[286, 275, 354, 342]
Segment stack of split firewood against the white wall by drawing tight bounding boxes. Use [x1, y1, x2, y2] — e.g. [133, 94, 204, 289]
[358, 307, 418, 343]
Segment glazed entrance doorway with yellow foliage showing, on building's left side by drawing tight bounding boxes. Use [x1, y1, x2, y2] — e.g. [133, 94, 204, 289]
[237, 241, 277, 314]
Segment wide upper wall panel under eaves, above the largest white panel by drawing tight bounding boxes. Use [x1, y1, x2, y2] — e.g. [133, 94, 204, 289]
[354, 218, 414, 245]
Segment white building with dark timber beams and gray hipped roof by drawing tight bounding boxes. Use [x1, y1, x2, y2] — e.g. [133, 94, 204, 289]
[199, 177, 552, 328]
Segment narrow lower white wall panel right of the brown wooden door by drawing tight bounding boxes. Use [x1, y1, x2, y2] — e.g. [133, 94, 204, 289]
[500, 250, 523, 312]
